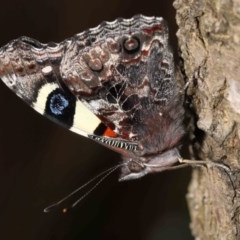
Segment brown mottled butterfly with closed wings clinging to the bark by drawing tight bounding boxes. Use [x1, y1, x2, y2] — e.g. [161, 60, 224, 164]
[0, 15, 184, 180]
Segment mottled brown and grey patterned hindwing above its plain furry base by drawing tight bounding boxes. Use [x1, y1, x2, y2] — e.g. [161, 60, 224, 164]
[60, 15, 175, 144]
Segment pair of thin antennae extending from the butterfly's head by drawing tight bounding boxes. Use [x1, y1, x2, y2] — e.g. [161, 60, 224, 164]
[43, 163, 125, 213]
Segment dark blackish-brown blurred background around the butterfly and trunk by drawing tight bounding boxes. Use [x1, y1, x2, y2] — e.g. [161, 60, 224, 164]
[0, 0, 193, 240]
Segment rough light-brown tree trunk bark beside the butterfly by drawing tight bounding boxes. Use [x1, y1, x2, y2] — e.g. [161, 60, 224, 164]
[174, 0, 240, 240]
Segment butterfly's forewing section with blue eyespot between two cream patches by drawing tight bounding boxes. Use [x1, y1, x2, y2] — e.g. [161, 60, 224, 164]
[0, 37, 105, 137]
